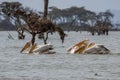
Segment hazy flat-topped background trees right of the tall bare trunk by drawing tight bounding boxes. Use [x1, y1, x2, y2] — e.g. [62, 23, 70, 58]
[49, 7, 114, 35]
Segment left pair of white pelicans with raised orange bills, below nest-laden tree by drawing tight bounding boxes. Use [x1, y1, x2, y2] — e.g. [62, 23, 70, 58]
[20, 42, 55, 54]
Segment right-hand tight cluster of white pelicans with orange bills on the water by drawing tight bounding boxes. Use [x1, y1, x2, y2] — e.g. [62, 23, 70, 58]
[67, 39, 110, 54]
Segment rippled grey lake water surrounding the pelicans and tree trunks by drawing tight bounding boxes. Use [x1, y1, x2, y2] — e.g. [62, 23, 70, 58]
[0, 32, 120, 80]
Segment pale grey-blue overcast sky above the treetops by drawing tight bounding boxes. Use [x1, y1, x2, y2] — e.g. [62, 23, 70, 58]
[0, 0, 120, 12]
